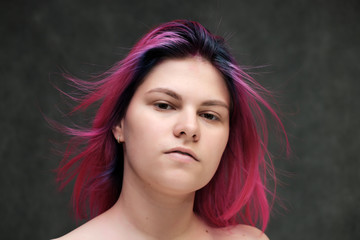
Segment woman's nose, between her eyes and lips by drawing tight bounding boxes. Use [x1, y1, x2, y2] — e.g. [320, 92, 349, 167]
[173, 110, 200, 142]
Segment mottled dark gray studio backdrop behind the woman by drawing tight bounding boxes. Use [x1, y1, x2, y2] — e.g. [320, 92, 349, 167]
[0, 0, 360, 239]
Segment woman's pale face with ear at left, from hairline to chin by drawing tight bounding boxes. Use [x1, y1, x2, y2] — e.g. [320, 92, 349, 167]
[113, 57, 230, 197]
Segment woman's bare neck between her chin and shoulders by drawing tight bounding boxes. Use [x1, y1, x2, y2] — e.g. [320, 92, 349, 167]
[109, 167, 204, 239]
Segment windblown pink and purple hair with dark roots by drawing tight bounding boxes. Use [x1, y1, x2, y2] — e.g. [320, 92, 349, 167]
[57, 20, 287, 230]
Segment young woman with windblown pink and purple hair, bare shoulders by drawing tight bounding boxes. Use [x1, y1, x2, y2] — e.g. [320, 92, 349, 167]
[53, 20, 286, 240]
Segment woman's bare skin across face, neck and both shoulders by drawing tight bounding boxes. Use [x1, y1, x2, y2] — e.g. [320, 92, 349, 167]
[52, 57, 268, 240]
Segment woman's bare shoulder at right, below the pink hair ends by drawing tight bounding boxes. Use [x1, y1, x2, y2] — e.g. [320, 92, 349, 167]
[215, 224, 269, 240]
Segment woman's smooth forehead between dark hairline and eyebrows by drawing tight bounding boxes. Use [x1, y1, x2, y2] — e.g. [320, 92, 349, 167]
[137, 56, 229, 103]
